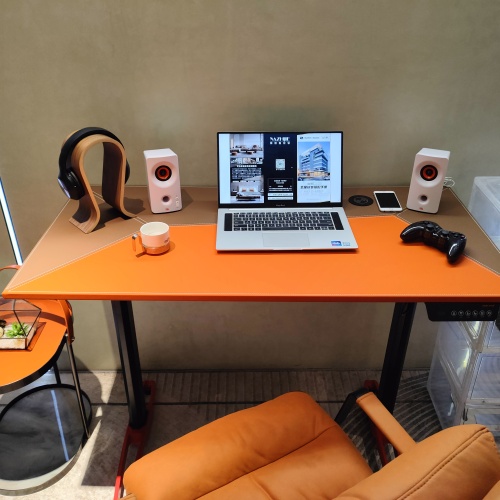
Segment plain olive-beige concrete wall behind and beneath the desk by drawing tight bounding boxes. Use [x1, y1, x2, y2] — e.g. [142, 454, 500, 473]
[0, 0, 500, 369]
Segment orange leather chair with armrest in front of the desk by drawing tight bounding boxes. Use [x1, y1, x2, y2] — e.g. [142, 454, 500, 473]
[124, 392, 500, 500]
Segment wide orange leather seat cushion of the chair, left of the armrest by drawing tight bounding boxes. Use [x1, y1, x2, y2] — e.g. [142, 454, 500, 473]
[124, 392, 372, 500]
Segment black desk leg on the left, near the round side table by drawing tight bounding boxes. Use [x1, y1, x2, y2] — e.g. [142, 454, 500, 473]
[111, 301, 147, 429]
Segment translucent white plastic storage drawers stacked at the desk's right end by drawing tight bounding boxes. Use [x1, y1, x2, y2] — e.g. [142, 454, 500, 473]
[427, 177, 500, 443]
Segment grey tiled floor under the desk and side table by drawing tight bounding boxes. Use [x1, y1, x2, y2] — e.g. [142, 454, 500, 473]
[0, 370, 439, 500]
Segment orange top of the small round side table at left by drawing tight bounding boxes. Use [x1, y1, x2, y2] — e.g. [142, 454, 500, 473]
[0, 301, 66, 393]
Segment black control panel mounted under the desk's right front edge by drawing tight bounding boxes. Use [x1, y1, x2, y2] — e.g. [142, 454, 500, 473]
[425, 302, 500, 321]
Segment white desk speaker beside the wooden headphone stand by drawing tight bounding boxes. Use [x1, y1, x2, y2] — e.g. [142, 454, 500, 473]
[144, 149, 182, 214]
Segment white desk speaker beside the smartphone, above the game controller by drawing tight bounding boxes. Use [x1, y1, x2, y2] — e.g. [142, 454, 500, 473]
[406, 148, 450, 214]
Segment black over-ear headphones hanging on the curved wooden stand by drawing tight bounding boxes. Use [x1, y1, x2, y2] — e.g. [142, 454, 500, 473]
[57, 127, 130, 200]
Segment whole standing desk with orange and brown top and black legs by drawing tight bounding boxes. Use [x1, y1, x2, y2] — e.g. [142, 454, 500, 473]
[3, 186, 500, 429]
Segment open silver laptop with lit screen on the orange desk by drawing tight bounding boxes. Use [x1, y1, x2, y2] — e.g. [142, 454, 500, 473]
[216, 132, 358, 252]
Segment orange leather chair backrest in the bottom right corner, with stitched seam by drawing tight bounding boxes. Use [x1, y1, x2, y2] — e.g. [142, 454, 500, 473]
[338, 425, 500, 500]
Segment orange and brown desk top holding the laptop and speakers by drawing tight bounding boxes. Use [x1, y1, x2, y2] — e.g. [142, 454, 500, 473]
[3, 188, 500, 302]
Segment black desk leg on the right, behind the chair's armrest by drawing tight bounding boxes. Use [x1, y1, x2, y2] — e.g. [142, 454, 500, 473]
[377, 302, 417, 413]
